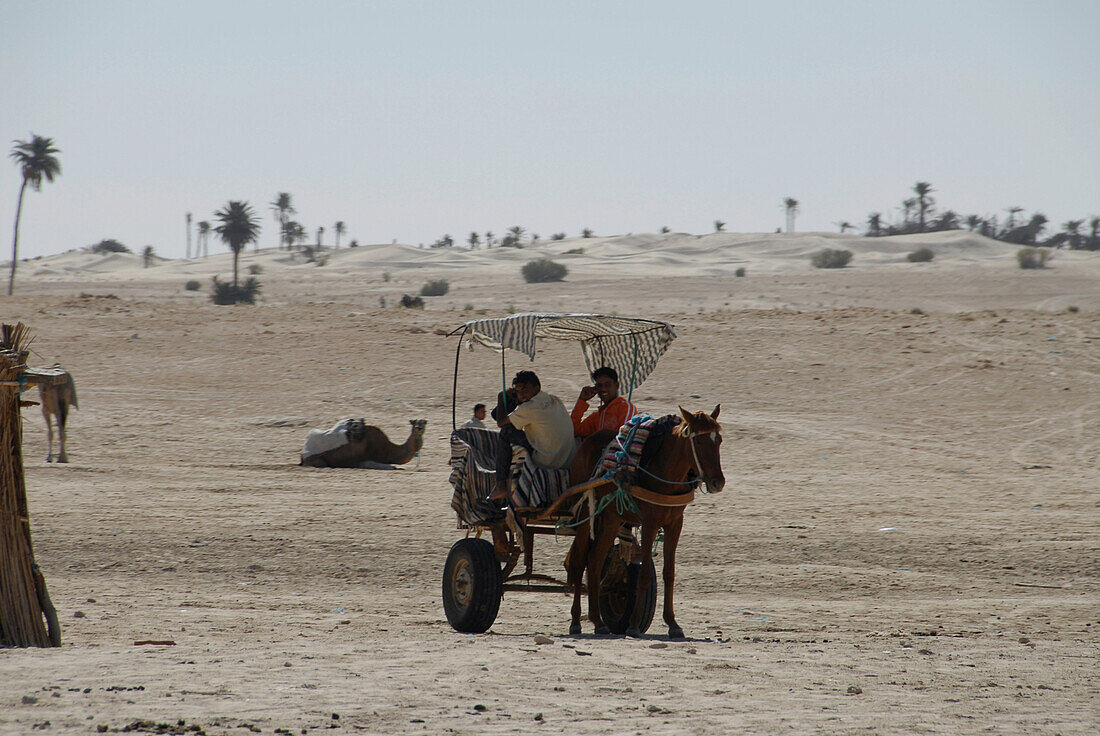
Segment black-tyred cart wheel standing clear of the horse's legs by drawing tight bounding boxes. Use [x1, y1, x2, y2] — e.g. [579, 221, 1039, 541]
[443, 537, 504, 634]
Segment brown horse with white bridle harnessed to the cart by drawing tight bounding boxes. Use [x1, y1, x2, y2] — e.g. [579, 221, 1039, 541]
[556, 405, 726, 639]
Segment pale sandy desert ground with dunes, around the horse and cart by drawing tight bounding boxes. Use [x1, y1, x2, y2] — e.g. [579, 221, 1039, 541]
[0, 235, 1100, 736]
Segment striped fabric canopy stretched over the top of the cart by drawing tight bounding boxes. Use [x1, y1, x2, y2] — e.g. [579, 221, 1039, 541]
[464, 312, 677, 388]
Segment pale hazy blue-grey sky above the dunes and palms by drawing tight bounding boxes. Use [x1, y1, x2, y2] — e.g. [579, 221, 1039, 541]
[0, 0, 1100, 257]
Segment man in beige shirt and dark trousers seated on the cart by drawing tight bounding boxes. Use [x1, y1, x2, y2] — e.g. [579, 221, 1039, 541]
[490, 371, 575, 501]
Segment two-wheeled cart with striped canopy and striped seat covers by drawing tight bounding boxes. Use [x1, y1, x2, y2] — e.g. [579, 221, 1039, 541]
[443, 314, 675, 634]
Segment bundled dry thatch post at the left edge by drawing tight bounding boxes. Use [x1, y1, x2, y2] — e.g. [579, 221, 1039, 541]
[0, 322, 62, 647]
